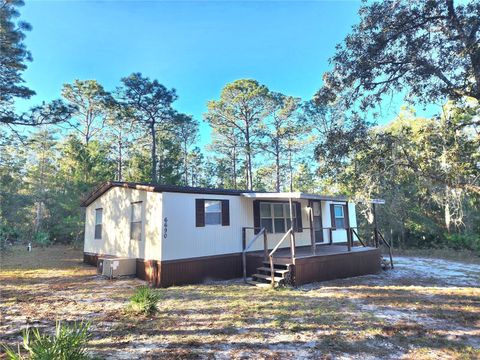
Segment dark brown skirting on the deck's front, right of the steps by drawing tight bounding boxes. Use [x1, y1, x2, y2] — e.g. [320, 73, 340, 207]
[295, 248, 381, 286]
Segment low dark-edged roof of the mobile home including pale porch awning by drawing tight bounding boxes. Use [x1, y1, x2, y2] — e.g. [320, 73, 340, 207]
[81, 181, 348, 207]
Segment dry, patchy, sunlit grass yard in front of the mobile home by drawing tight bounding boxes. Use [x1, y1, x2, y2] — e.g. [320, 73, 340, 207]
[0, 247, 480, 359]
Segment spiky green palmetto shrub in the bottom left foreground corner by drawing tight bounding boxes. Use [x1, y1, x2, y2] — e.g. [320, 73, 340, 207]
[5, 321, 90, 360]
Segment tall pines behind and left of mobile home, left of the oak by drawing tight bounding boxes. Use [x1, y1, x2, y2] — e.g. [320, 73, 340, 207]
[0, 73, 320, 243]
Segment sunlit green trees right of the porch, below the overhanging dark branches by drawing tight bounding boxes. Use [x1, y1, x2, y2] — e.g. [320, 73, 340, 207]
[317, 101, 480, 248]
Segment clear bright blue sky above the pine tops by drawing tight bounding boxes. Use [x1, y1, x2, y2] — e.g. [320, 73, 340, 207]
[19, 0, 418, 145]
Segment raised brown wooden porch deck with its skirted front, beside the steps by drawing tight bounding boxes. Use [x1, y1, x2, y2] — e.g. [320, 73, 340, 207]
[247, 244, 381, 285]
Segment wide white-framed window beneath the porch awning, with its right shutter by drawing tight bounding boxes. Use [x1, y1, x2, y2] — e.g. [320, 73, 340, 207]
[260, 202, 296, 233]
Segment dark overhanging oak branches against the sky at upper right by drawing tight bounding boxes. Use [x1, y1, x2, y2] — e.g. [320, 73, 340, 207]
[316, 0, 480, 110]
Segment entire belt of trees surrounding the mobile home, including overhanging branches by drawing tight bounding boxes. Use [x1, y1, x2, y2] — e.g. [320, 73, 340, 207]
[0, 0, 480, 252]
